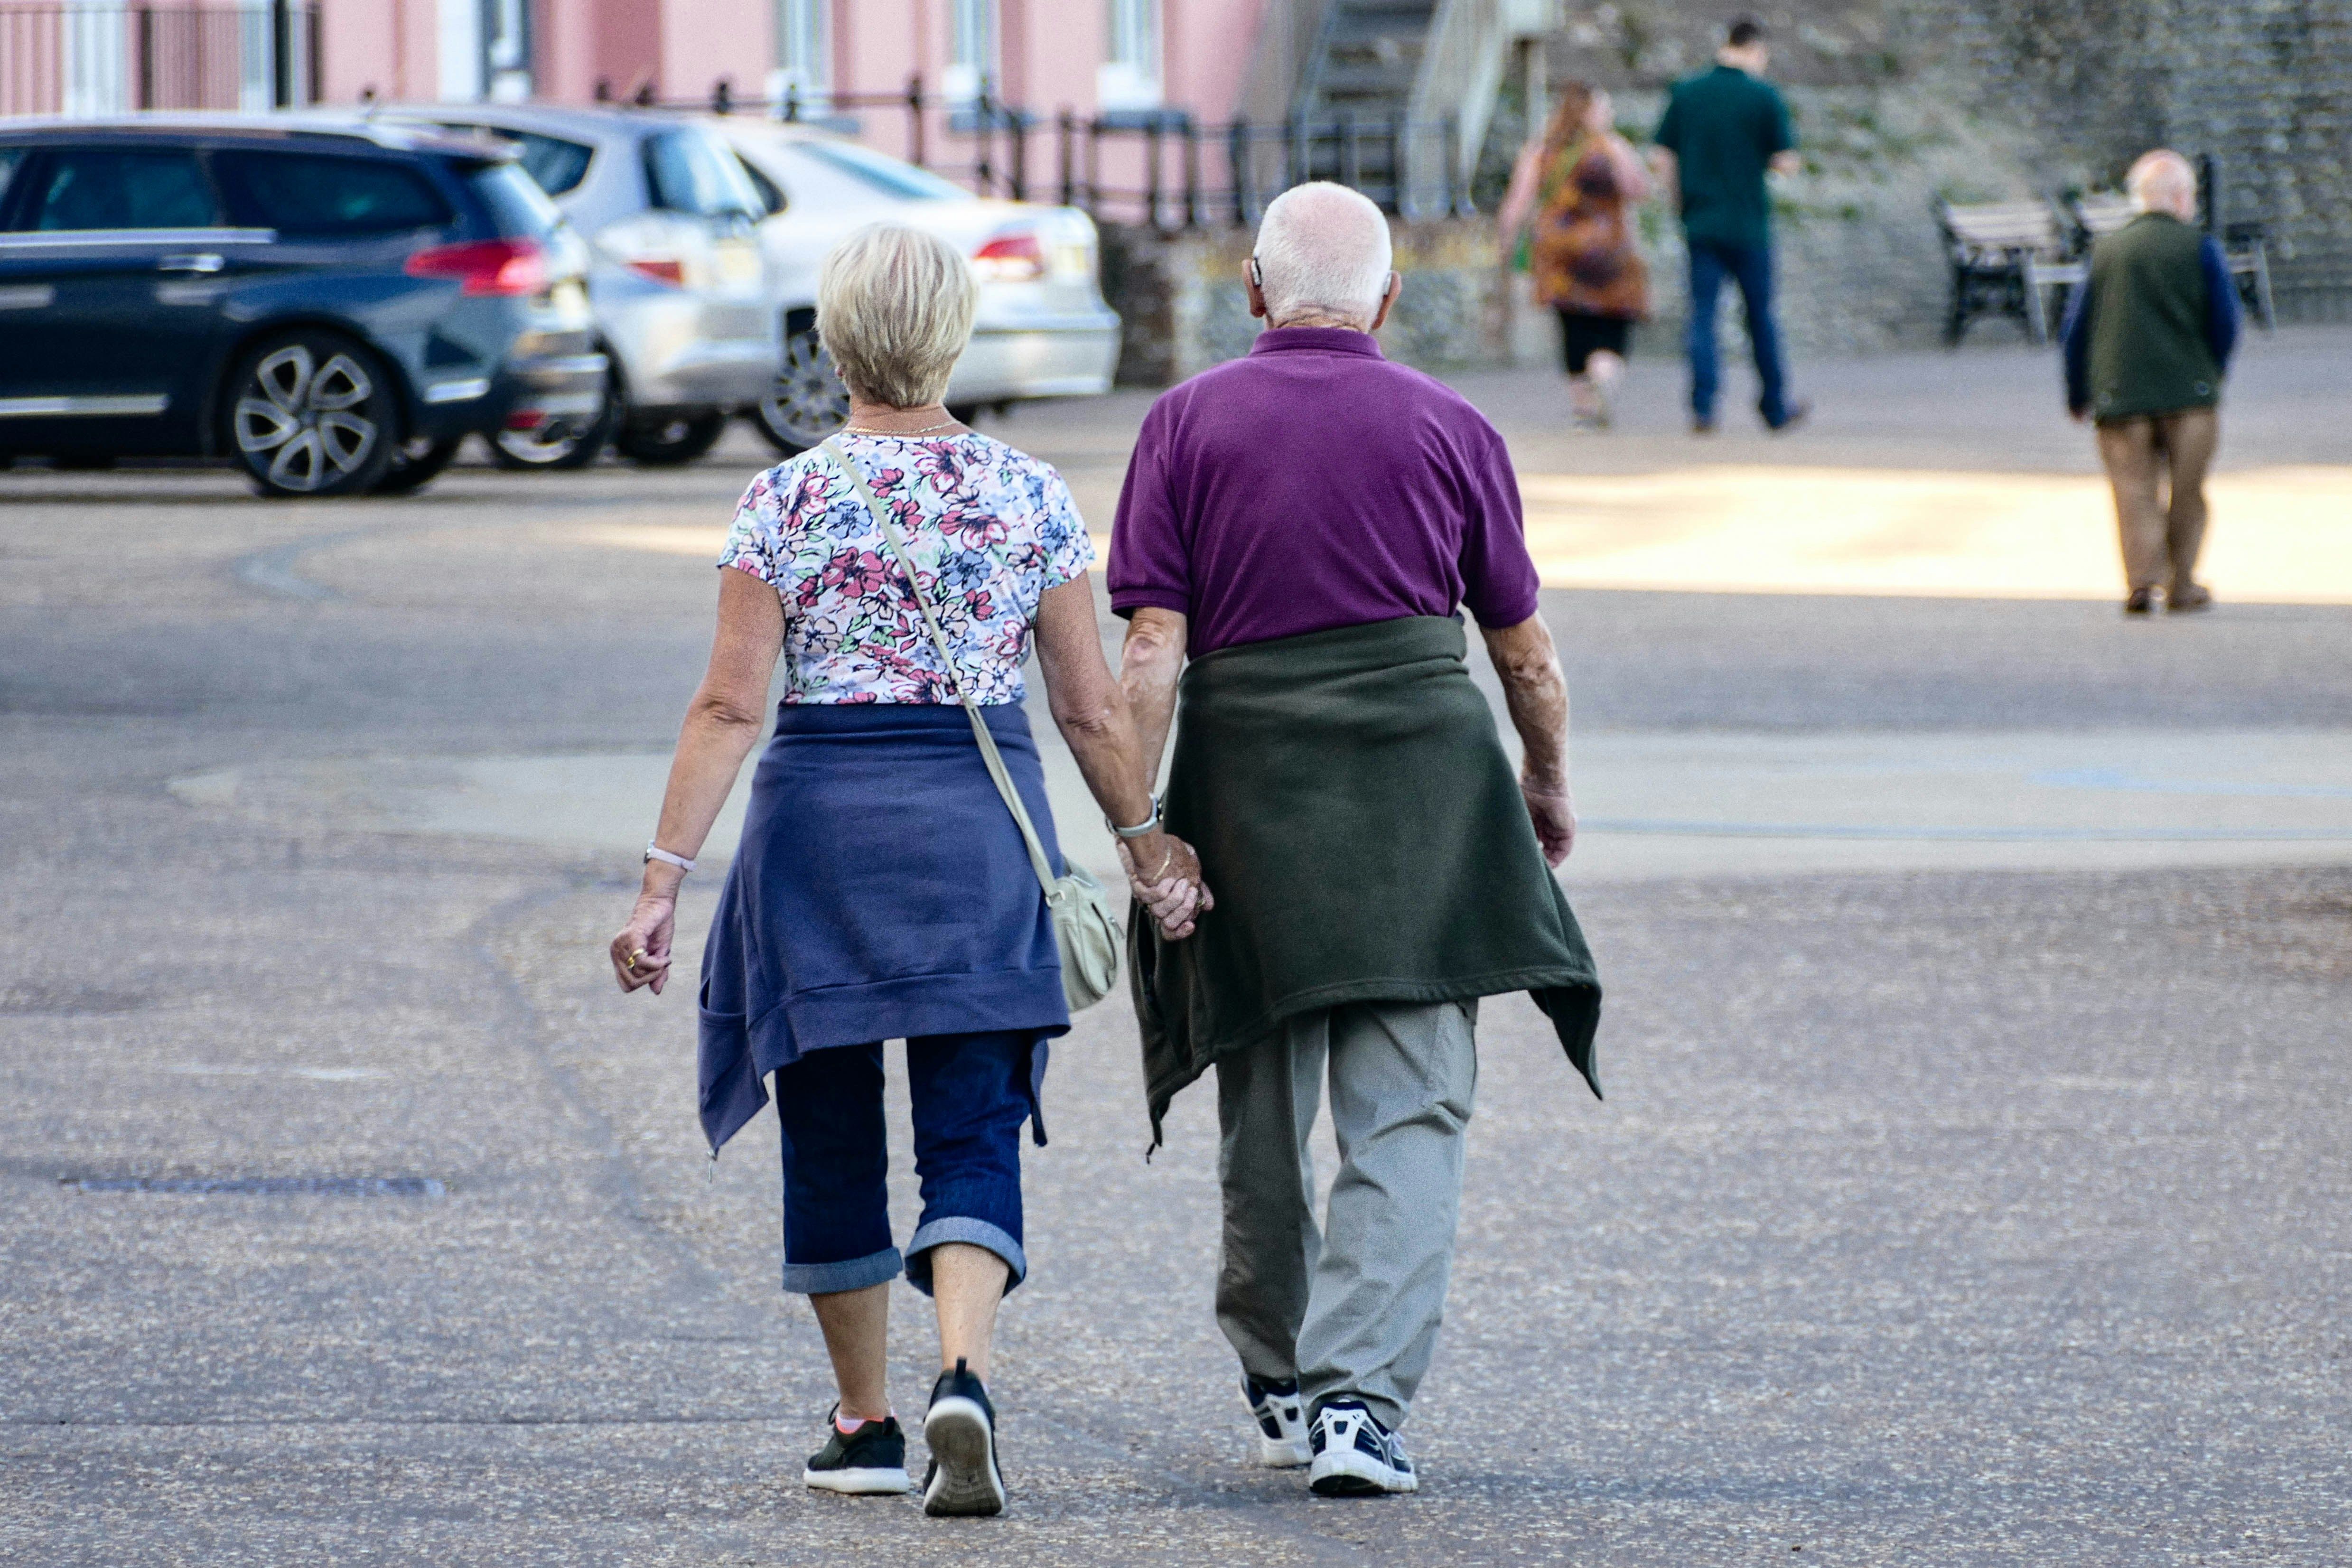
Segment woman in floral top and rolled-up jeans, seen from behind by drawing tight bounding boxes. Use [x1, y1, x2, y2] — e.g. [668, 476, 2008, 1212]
[612, 226, 1209, 1514]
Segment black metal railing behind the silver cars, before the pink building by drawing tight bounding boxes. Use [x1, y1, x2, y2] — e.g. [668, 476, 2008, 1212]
[616, 75, 1477, 230]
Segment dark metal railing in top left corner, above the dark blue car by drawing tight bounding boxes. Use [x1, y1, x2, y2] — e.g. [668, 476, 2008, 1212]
[0, 0, 320, 115]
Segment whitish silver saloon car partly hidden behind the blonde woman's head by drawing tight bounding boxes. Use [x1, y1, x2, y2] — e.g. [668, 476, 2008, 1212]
[703, 118, 1120, 456]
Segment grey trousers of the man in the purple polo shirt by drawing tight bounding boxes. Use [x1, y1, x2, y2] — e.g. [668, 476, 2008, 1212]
[1216, 1001, 1477, 1429]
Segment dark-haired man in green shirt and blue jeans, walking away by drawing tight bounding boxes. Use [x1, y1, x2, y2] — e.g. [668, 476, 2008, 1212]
[1656, 17, 1811, 435]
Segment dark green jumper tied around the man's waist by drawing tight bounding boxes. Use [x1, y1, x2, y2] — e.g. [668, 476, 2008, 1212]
[1129, 616, 1602, 1145]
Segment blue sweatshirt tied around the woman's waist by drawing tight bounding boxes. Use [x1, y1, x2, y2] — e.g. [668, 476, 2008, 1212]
[701, 703, 1070, 1154]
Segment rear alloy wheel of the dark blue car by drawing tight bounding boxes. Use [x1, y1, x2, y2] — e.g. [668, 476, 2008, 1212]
[228, 327, 398, 496]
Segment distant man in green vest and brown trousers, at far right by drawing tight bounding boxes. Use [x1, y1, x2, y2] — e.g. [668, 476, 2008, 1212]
[2063, 148, 2237, 616]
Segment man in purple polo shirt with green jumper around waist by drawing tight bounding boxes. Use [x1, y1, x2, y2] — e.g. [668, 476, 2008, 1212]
[1110, 183, 1599, 1495]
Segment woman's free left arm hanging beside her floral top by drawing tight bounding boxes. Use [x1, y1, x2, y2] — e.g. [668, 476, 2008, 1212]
[612, 569, 783, 997]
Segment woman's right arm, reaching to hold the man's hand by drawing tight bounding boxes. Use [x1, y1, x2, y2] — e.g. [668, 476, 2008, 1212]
[1037, 579, 1216, 938]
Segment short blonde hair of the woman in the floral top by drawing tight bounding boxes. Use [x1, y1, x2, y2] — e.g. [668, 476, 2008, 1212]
[816, 224, 981, 409]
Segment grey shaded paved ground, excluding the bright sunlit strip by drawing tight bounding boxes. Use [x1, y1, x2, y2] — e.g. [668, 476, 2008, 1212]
[0, 334, 2352, 1568]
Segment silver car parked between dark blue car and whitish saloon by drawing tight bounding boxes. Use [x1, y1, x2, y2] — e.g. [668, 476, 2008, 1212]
[379, 103, 781, 468]
